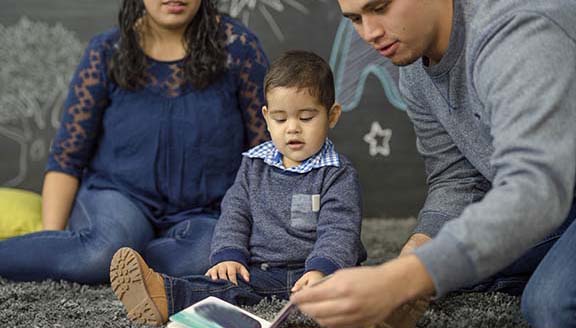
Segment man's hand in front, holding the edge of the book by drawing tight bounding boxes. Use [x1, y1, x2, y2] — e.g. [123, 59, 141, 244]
[291, 255, 434, 328]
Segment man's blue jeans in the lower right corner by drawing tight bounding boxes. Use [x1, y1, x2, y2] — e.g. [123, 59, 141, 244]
[465, 204, 576, 327]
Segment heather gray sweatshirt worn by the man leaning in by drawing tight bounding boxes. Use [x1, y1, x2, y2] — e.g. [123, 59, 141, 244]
[400, 0, 576, 296]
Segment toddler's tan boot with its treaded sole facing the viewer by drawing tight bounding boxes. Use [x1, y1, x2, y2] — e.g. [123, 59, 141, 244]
[110, 247, 168, 325]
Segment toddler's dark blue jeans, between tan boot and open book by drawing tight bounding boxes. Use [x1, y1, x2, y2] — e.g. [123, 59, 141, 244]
[164, 264, 304, 315]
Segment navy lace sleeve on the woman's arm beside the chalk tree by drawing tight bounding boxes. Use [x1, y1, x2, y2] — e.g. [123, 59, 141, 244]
[46, 38, 109, 177]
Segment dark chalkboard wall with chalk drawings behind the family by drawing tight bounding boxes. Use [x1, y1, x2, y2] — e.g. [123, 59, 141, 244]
[0, 0, 425, 217]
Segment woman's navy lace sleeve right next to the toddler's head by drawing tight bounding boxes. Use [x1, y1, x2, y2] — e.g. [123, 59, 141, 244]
[238, 33, 270, 148]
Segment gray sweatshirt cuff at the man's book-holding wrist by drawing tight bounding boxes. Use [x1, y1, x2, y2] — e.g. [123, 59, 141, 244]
[414, 231, 479, 298]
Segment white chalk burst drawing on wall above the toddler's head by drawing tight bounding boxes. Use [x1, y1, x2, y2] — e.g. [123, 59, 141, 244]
[219, 0, 326, 41]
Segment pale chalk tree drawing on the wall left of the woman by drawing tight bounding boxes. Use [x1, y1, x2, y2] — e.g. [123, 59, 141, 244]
[0, 18, 83, 186]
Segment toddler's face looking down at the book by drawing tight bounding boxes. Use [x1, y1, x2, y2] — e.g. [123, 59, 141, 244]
[262, 87, 340, 168]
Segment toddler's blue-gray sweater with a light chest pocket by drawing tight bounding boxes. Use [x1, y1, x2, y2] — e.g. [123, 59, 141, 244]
[210, 155, 366, 274]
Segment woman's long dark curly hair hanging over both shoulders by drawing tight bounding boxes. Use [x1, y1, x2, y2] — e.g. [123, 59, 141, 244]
[109, 0, 227, 90]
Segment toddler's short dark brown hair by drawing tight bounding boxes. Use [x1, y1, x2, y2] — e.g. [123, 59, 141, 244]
[264, 50, 335, 110]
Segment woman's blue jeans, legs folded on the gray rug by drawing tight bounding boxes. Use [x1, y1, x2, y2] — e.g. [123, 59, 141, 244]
[0, 188, 217, 284]
